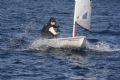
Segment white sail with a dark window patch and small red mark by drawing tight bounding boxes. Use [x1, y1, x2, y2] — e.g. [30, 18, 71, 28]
[74, 0, 91, 30]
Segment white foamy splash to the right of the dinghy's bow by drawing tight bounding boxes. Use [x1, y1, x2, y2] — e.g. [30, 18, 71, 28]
[86, 41, 120, 52]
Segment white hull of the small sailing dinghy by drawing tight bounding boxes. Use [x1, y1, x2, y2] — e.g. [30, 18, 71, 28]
[48, 36, 86, 49]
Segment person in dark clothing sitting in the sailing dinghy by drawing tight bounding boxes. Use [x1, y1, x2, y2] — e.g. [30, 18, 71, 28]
[41, 17, 60, 39]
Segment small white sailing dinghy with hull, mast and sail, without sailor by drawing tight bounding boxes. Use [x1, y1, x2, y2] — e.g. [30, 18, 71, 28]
[31, 0, 91, 49]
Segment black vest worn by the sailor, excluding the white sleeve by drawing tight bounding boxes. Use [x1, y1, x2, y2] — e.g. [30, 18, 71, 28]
[41, 24, 59, 39]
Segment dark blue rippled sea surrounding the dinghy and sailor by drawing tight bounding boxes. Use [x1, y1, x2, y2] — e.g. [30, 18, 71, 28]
[0, 0, 120, 80]
